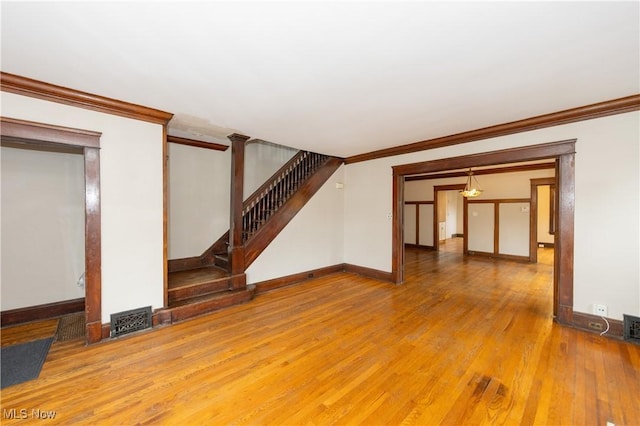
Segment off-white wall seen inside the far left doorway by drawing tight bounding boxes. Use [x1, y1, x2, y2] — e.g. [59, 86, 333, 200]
[0, 145, 85, 311]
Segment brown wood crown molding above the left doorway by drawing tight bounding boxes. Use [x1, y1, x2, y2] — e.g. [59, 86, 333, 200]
[0, 71, 173, 125]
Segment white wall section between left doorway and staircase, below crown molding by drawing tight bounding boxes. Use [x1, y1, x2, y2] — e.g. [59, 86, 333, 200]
[0, 92, 164, 323]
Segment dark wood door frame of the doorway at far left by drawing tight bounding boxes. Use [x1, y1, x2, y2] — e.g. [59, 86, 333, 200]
[0, 117, 102, 343]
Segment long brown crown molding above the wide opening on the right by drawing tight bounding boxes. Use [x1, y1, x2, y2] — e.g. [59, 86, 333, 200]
[345, 94, 640, 164]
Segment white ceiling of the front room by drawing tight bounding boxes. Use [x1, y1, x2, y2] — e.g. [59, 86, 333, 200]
[1, 1, 640, 157]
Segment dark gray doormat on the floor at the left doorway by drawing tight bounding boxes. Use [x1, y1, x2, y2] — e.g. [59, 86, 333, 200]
[0, 337, 53, 389]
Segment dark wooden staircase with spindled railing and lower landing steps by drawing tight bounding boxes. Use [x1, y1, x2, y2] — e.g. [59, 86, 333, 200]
[158, 151, 342, 322]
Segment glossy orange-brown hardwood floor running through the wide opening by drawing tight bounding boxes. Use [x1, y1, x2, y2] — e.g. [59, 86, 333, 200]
[1, 249, 640, 425]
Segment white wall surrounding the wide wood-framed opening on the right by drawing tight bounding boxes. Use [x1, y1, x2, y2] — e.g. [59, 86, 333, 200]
[344, 112, 640, 319]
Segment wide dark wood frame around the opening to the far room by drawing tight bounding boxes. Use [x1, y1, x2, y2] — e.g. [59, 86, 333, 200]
[391, 139, 576, 324]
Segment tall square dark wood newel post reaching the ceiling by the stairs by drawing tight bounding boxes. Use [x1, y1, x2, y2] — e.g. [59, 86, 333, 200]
[228, 133, 249, 289]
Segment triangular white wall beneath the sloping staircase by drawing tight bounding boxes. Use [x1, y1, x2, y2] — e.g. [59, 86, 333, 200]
[247, 166, 348, 284]
